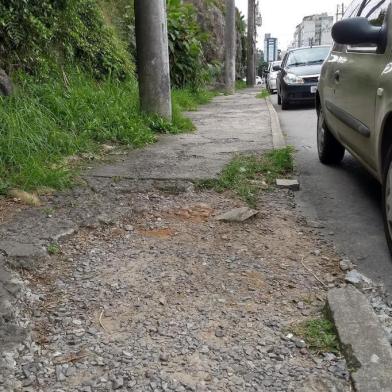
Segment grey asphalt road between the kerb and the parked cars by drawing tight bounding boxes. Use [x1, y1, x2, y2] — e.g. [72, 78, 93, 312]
[271, 95, 392, 295]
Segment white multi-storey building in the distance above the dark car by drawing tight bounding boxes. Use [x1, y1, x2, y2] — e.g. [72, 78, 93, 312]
[292, 13, 334, 48]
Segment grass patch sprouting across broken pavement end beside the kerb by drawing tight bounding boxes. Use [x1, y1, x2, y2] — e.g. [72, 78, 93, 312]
[198, 147, 294, 207]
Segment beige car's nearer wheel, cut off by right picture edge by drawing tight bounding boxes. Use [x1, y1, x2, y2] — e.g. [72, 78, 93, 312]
[382, 146, 392, 254]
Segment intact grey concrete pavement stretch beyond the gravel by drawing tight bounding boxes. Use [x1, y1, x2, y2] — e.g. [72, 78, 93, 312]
[88, 88, 272, 180]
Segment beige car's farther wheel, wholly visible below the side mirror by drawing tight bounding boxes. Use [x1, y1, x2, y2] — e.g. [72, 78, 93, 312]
[317, 108, 345, 165]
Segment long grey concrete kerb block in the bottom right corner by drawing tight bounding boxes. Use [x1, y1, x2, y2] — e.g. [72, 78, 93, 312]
[328, 286, 392, 392]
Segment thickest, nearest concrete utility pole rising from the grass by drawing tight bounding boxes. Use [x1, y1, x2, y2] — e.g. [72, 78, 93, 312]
[135, 0, 172, 120]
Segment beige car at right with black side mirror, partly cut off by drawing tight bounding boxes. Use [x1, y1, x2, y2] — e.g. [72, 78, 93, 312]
[316, 0, 392, 252]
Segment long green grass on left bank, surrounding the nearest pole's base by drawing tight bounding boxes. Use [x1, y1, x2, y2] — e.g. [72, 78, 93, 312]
[0, 71, 213, 193]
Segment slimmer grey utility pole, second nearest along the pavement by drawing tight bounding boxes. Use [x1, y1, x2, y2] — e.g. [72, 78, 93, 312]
[225, 0, 237, 94]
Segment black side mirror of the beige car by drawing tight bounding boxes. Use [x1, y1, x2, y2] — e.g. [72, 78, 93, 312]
[332, 17, 384, 46]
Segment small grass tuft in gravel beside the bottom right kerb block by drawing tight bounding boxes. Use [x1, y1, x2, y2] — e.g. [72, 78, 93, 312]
[292, 318, 339, 353]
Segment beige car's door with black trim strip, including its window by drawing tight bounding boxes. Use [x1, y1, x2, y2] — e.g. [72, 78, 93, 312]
[326, 0, 391, 169]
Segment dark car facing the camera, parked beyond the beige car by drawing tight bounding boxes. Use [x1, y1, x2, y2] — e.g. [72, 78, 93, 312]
[277, 46, 331, 110]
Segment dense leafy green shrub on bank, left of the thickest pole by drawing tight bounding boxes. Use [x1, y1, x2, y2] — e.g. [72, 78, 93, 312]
[0, 0, 133, 78]
